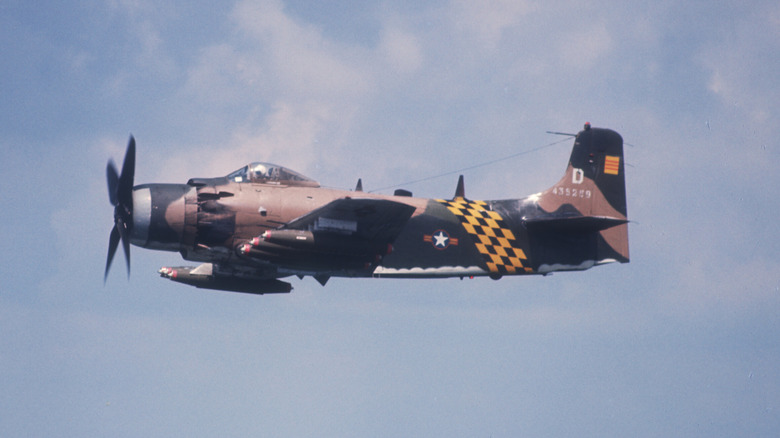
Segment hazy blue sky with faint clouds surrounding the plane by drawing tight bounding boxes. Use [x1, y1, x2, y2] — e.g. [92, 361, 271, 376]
[0, 0, 780, 437]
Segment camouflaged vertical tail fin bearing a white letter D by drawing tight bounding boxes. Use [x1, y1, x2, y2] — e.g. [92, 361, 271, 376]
[527, 124, 629, 263]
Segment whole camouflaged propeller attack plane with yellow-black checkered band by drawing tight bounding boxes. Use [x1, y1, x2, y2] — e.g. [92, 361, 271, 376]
[104, 124, 629, 294]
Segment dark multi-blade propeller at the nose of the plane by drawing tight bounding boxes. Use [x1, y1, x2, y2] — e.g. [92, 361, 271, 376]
[103, 135, 135, 284]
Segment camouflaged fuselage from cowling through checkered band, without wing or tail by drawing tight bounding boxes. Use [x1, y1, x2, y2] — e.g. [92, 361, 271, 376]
[131, 178, 592, 278]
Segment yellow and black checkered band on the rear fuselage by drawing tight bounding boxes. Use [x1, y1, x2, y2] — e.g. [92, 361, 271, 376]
[437, 198, 531, 274]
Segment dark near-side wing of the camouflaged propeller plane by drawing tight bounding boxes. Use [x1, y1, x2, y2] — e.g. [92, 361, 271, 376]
[281, 198, 415, 243]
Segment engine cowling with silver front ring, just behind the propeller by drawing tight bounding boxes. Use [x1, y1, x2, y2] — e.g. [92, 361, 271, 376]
[130, 184, 194, 251]
